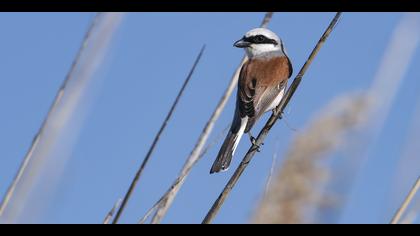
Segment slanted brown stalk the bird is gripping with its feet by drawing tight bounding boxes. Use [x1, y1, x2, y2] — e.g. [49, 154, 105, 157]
[202, 12, 341, 224]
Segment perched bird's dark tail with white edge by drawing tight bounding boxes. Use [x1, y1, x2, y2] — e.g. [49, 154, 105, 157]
[210, 131, 240, 174]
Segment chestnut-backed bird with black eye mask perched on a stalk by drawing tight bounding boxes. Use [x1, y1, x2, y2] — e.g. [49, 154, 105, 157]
[210, 28, 293, 174]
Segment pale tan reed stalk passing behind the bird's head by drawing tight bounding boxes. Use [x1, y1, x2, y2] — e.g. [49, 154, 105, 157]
[148, 12, 273, 224]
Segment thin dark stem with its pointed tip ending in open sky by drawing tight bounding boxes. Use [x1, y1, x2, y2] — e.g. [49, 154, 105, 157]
[112, 45, 205, 224]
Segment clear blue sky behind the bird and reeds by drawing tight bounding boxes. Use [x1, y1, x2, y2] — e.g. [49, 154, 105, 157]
[0, 13, 420, 223]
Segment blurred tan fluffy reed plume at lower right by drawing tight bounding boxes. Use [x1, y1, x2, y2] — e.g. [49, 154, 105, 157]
[253, 94, 368, 224]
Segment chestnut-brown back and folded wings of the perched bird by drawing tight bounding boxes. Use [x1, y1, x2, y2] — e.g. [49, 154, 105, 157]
[237, 56, 291, 133]
